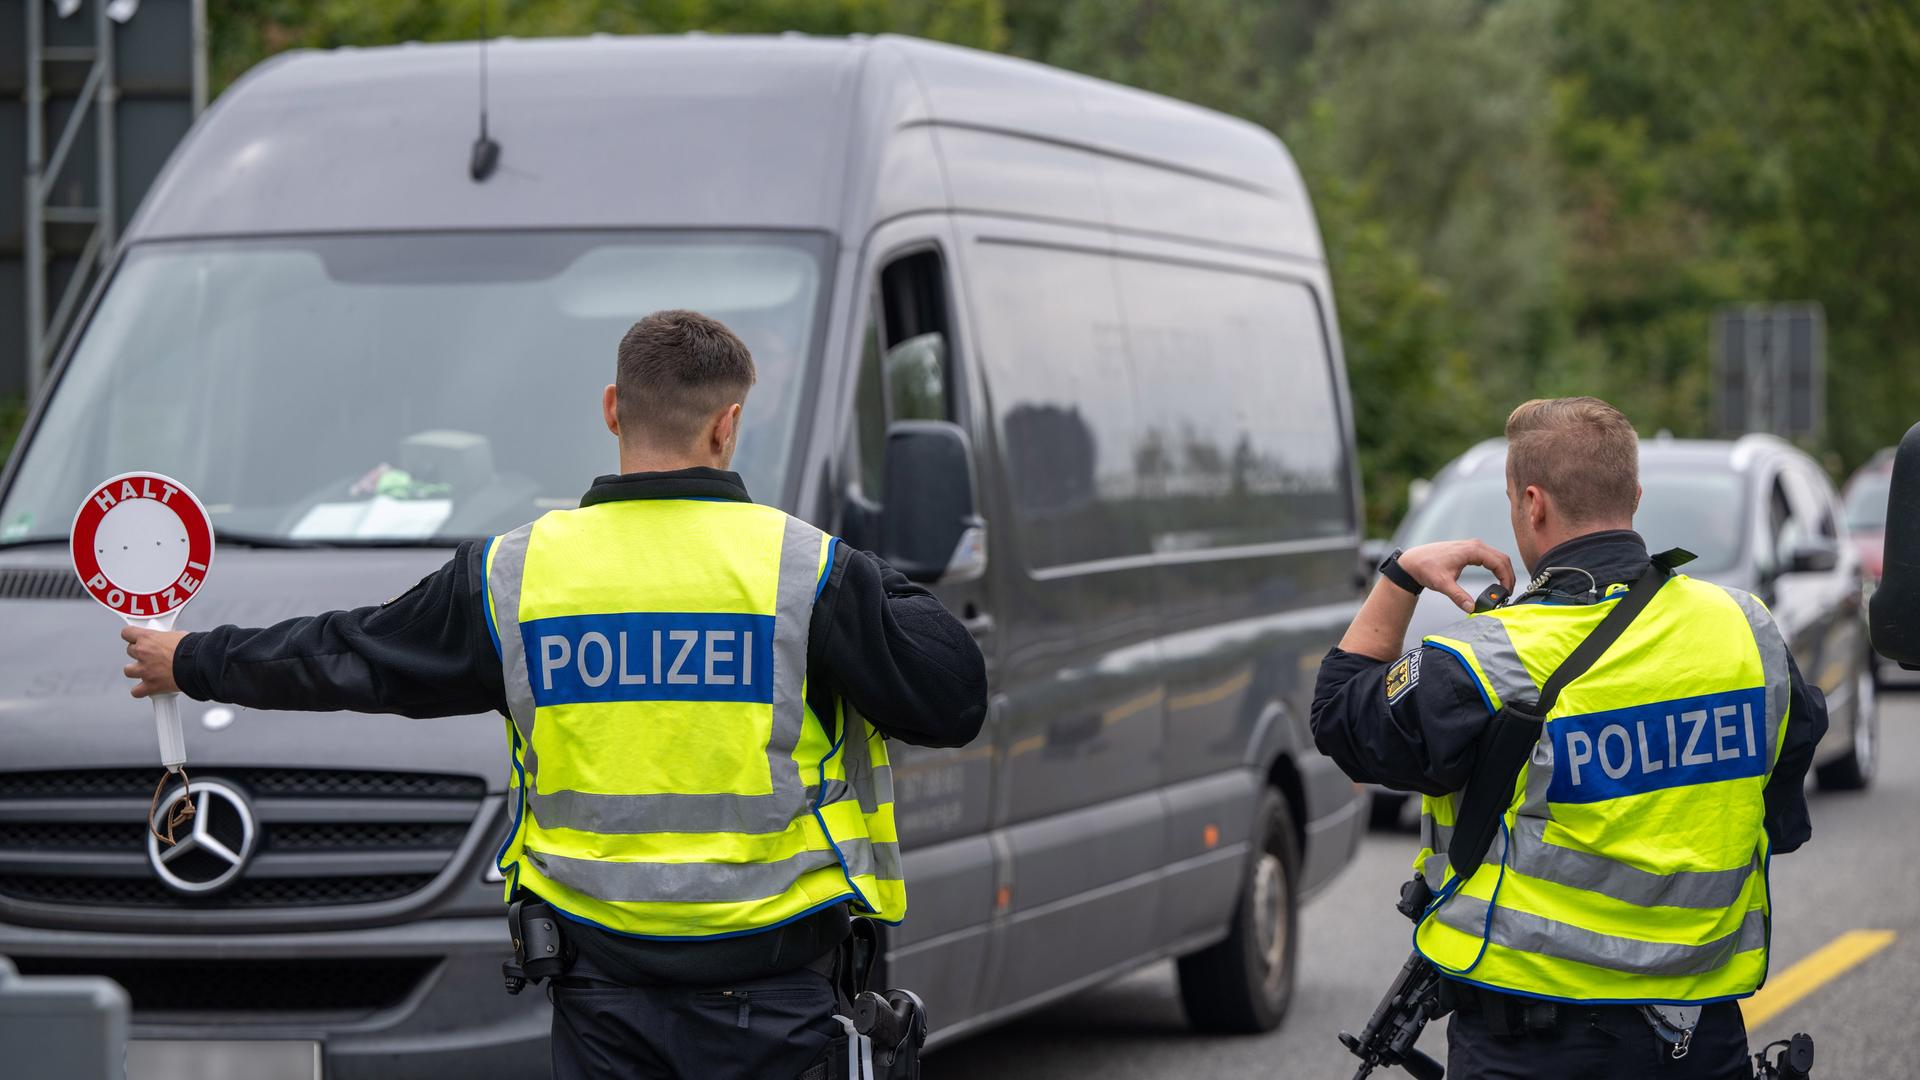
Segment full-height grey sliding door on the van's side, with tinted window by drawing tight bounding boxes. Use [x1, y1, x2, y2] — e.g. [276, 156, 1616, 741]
[956, 219, 1165, 1009]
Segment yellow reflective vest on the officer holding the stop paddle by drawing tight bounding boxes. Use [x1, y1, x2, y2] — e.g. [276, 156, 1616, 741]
[486, 500, 906, 938]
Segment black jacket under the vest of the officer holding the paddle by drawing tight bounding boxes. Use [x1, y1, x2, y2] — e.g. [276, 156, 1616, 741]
[173, 469, 987, 984]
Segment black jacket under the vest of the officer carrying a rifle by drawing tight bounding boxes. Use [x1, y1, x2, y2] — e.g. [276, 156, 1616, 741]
[1311, 528, 1826, 855]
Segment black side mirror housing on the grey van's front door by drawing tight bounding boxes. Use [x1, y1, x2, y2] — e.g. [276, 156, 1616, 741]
[879, 421, 987, 584]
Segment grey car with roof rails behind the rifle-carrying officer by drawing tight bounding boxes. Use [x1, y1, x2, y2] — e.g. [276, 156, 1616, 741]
[1373, 434, 1880, 822]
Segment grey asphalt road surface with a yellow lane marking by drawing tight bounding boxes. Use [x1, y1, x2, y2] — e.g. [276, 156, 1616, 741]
[924, 690, 1920, 1080]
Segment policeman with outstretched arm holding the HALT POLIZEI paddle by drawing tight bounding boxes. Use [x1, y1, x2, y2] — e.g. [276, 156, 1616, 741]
[125, 311, 987, 1080]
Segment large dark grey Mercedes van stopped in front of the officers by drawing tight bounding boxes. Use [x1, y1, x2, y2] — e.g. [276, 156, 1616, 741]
[0, 37, 1365, 1076]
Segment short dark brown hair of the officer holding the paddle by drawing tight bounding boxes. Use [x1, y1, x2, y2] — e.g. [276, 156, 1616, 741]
[614, 309, 756, 448]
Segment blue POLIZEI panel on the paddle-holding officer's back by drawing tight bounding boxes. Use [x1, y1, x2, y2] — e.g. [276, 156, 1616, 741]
[520, 611, 774, 707]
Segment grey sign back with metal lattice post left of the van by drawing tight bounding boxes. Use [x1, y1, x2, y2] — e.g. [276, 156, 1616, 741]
[0, 0, 207, 396]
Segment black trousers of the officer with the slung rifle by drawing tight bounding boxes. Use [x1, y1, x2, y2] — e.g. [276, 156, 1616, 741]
[1446, 1001, 1753, 1080]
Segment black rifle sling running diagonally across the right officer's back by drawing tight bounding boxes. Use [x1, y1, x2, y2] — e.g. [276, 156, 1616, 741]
[1446, 550, 1693, 880]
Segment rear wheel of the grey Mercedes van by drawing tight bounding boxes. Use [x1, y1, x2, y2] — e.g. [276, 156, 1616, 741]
[1179, 788, 1300, 1034]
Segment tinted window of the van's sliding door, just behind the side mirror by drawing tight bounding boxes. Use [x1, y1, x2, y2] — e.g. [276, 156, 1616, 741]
[970, 242, 1146, 571]
